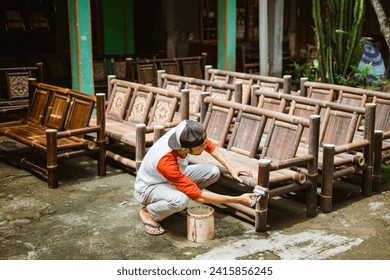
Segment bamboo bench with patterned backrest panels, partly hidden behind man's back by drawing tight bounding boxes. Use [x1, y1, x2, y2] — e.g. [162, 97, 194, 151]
[91, 76, 189, 170]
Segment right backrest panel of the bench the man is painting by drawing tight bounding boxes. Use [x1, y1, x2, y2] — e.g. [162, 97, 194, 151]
[260, 120, 303, 161]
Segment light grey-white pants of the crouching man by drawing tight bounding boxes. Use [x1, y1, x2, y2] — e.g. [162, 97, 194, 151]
[143, 164, 220, 221]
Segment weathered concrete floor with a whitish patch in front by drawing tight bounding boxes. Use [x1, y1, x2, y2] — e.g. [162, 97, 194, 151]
[0, 140, 390, 260]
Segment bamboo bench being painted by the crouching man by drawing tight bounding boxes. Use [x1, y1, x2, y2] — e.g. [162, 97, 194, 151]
[190, 97, 319, 232]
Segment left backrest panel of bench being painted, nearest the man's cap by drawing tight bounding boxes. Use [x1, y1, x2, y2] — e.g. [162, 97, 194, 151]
[203, 103, 234, 147]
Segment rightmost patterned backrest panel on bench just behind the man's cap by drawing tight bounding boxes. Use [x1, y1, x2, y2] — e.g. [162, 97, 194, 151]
[148, 94, 178, 125]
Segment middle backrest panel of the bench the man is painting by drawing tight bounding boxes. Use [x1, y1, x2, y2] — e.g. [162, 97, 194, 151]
[227, 110, 267, 158]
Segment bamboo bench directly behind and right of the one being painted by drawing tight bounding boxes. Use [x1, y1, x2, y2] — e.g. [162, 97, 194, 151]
[252, 89, 375, 212]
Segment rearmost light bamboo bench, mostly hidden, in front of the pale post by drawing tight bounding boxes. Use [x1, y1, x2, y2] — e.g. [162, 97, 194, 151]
[204, 65, 292, 104]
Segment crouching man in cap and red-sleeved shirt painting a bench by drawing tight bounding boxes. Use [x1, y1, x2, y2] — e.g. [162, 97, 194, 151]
[134, 120, 255, 235]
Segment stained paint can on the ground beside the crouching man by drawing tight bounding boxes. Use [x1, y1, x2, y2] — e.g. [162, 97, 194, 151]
[187, 205, 214, 242]
